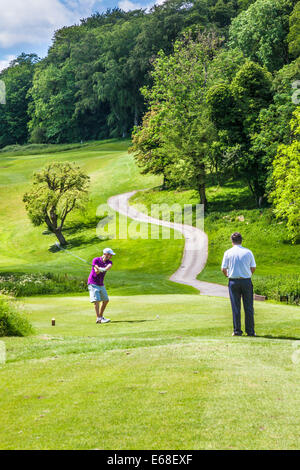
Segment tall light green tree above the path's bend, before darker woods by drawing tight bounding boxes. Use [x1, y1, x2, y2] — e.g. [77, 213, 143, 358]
[139, 31, 221, 205]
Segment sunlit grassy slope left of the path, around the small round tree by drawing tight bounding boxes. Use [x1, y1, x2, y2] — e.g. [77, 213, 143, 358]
[0, 141, 195, 295]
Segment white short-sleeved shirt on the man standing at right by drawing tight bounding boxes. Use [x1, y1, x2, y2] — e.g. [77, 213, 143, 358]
[222, 245, 256, 278]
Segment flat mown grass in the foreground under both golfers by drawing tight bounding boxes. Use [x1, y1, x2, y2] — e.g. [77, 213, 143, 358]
[0, 295, 300, 449]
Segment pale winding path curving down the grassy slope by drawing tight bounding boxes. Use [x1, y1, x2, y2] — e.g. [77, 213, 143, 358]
[107, 191, 228, 297]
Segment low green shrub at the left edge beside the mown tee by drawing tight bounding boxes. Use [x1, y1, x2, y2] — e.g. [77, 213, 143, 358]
[0, 297, 33, 337]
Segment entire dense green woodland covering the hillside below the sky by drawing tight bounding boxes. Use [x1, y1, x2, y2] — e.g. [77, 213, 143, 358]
[0, 0, 300, 241]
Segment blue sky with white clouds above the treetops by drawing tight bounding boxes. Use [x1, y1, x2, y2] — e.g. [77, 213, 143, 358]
[0, 0, 164, 71]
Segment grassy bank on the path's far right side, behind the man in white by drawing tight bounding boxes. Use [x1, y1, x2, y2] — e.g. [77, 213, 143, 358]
[131, 181, 300, 284]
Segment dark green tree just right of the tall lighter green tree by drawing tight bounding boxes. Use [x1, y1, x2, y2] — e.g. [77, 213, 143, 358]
[207, 61, 272, 205]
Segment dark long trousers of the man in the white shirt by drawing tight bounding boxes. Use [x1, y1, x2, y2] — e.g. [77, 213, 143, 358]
[228, 278, 254, 335]
